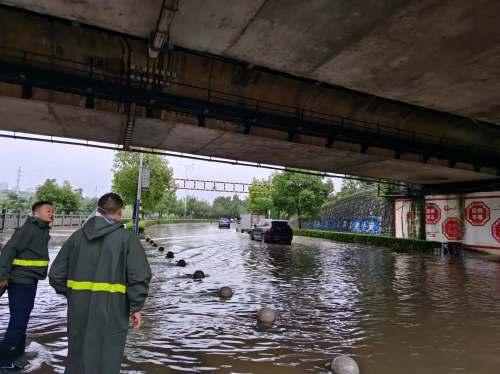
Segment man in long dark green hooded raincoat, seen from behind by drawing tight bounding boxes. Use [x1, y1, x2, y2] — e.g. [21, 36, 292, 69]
[49, 193, 151, 374]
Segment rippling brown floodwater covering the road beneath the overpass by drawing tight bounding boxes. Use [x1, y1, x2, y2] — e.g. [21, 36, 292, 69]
[0, 224, 500, 374]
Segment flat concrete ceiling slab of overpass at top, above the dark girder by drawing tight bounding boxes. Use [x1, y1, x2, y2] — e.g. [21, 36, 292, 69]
[2, 0, 500, 124]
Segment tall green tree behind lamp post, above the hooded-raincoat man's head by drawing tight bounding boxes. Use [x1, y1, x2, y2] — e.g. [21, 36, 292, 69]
[111, 152, 173, 213]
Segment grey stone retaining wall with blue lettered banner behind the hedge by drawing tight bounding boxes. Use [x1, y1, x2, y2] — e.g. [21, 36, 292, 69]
[294, 191, 394, 236]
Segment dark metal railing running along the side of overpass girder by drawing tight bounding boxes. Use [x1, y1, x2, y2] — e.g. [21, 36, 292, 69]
[0, 46, 500, 155]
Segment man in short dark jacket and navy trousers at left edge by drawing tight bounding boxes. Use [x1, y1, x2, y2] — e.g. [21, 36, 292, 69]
[0, 201, 54, 372]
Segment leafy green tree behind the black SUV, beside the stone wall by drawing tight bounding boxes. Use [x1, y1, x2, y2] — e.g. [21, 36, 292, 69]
[272, 171, 333, 227]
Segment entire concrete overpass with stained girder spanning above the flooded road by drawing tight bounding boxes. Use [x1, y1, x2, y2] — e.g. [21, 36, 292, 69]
[0, 0, 500, 184]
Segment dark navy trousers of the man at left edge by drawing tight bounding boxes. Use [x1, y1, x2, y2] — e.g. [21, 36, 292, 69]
[0, 281, 38, 364]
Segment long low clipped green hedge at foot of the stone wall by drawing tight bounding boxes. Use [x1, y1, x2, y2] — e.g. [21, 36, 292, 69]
[293, 229, 441, 252]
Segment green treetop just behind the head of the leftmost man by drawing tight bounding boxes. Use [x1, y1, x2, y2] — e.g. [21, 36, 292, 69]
[34, 179, 83, 213]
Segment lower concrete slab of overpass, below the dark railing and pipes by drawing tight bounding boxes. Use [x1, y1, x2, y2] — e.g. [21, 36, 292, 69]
[0, 94, 495, 184]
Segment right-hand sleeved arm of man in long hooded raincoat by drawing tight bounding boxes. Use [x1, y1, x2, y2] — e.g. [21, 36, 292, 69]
[127, 235, 151, 312]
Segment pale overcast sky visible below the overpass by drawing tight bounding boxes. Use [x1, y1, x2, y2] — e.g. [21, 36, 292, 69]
[0, 138, 341, 202]
